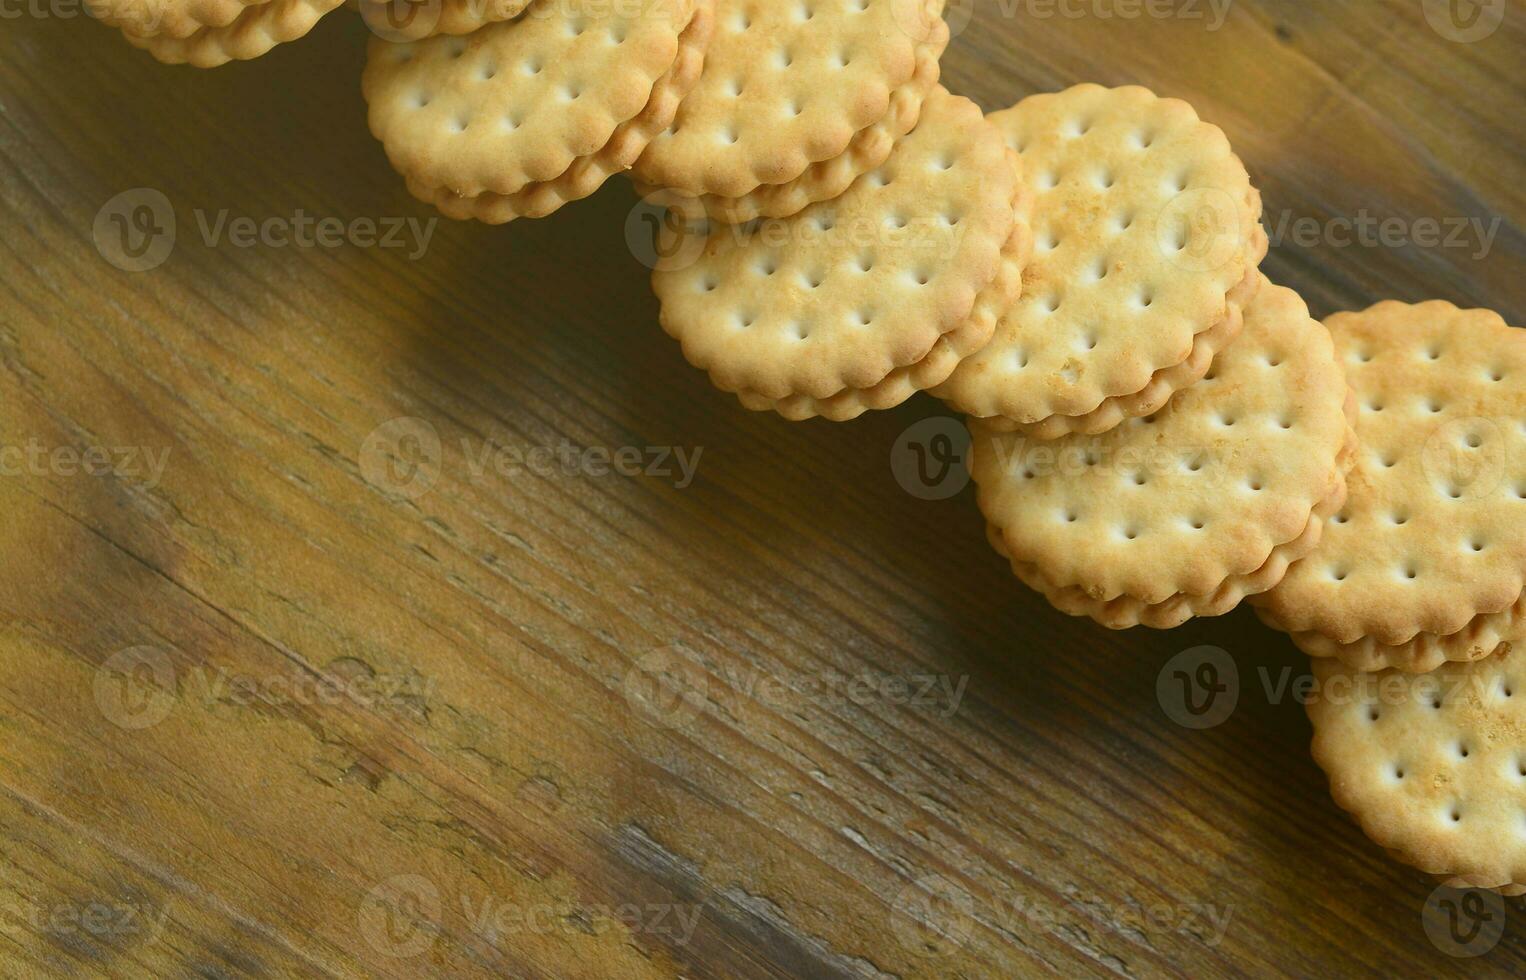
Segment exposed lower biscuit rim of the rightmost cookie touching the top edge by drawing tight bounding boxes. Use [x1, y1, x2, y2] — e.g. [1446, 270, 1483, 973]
[638, 20, 948, 224]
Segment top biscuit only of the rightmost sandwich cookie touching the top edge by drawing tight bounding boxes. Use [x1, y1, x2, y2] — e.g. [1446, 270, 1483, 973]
[635, 0, 948, 198]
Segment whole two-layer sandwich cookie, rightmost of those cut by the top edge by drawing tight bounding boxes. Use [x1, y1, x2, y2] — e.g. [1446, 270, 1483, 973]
[632, 0, 949, 223]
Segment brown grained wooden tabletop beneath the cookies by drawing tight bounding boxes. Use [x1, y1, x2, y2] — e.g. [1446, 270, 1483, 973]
[0, 0, 1526, 977]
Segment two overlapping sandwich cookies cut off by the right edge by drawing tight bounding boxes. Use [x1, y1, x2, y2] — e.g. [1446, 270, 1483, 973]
[1254, 302, 1526, 895]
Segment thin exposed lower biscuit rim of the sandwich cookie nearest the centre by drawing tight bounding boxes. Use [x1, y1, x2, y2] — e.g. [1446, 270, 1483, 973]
[737, 181, 1033, 421]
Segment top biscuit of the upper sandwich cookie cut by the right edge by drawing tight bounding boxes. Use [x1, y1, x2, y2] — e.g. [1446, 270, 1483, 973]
[1262, 302, 1526, 647]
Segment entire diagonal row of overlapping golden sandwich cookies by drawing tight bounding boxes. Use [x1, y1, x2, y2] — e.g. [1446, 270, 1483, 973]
[119, 0, 1526, 893]
